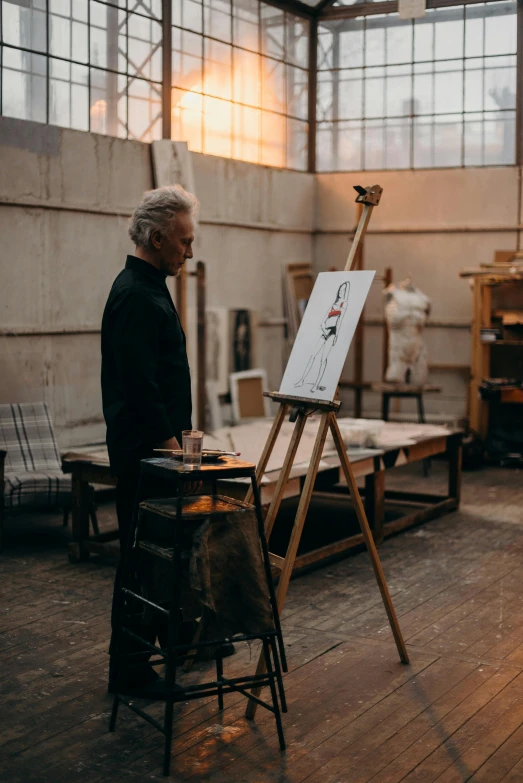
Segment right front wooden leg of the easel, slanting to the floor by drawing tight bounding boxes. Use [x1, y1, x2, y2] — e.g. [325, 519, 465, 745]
[329, 414, 409, 663]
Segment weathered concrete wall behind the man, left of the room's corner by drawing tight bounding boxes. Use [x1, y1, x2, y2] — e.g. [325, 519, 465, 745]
[0, 117, 314, 448]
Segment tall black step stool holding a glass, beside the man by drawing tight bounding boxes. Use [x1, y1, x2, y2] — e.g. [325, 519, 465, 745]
[109, 458, 287, 775]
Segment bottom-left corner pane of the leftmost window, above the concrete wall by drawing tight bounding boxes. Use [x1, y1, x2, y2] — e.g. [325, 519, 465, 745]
[2, 49, 47, 122]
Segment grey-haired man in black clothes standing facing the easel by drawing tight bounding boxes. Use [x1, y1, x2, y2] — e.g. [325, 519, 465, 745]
[102, 185, 198, 694]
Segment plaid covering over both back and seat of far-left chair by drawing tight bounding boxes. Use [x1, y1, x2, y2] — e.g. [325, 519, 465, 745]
[0, 402, 71, 509]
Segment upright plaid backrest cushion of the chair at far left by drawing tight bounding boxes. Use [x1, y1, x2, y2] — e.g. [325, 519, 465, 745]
[0, 402, 61, 474]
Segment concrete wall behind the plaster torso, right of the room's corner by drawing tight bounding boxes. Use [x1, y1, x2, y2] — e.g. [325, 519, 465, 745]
[314, 167, 520, 418]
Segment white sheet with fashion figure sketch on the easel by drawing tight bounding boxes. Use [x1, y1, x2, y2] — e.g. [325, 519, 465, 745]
[280, 271, 375, 400]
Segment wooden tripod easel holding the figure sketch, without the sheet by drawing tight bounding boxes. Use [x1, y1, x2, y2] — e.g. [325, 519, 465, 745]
[245, 185, 409, 718]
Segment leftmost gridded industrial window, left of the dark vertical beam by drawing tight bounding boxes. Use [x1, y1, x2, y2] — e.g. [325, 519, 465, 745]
[0, 0, 162, 141]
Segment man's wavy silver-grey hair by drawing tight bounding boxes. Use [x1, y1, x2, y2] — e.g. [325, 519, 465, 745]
[129, 185, 199, 247]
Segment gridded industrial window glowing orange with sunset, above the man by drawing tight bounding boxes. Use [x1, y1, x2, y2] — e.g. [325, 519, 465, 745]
[172, 0, 308, 169]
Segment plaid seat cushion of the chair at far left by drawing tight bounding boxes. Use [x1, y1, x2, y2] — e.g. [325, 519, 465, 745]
[4, 471, 71, 509]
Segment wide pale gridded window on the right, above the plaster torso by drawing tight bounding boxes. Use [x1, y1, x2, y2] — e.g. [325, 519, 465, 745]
[317, 0, 517, 171]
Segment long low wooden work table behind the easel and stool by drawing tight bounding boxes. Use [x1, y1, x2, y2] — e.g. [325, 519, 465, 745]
[63, 423, 462, 568]
